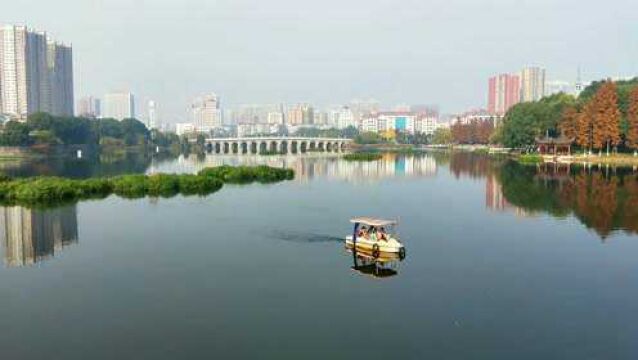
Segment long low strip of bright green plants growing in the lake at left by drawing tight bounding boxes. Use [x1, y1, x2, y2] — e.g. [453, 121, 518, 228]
[0, 166, 294, 205]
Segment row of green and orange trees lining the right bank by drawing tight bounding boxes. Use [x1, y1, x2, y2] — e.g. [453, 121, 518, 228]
[500, 78, 638, 152]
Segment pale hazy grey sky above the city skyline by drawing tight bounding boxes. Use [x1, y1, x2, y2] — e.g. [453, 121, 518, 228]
[0, 0, 638, 120]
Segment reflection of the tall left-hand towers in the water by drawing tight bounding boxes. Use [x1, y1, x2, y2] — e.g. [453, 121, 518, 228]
[0, 205, 78, 267]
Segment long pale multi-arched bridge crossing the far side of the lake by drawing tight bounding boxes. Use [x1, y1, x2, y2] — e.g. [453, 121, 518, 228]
[206, 136, 352, 154]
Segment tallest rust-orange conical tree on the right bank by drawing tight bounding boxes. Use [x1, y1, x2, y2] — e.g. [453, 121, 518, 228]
[592, 81, 620, 153]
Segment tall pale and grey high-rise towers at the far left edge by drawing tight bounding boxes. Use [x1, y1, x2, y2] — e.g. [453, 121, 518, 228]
[0, 25, 73, 120]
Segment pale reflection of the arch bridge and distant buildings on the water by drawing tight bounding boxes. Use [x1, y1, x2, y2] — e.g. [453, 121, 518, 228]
[148, 153, 437, 183]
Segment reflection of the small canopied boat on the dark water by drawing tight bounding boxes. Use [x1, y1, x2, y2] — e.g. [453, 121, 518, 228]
[346, 246, 405, 279]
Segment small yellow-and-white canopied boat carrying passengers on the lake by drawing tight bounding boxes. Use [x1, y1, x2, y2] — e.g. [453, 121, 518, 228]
[346, 217, 405, 260]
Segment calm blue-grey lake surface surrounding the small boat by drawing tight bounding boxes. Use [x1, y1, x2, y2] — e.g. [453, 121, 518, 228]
[0, 154, 638, 359]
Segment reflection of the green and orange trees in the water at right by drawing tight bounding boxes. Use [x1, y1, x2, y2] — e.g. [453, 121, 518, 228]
[499, 162, 638, 240]
